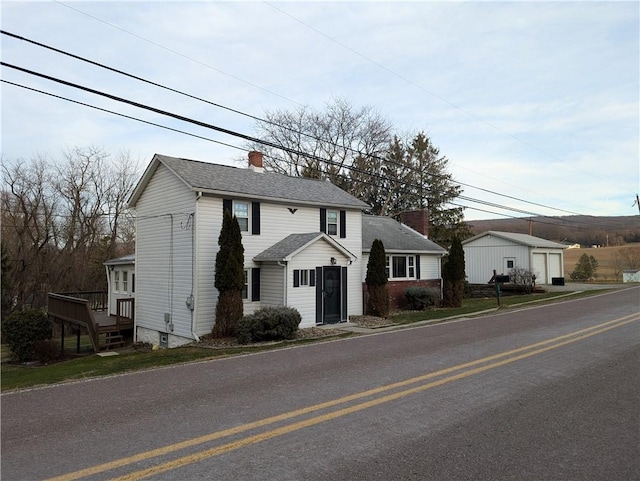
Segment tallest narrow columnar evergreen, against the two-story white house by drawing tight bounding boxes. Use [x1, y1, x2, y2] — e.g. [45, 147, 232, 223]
[212, 210, 244, 337]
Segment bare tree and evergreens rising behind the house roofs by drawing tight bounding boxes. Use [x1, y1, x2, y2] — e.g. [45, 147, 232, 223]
[247, 98, 471, 248]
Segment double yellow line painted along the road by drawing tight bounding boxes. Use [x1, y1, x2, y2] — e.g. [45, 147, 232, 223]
[48, 314, 640, 481]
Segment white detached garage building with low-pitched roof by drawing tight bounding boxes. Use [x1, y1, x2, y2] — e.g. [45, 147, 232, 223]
[462, 231, 566, 284]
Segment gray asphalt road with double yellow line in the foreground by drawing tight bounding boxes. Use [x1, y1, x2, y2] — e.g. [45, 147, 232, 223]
[1, 288, 640, 481]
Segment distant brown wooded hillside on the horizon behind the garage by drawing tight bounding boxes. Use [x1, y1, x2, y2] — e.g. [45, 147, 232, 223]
[468, 215, 640, 246]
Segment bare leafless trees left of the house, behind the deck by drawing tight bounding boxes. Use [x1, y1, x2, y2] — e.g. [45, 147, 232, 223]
[0, 147, 139, 316]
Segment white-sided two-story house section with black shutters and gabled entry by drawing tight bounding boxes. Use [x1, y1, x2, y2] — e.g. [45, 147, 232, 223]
[129, 152, 367, 347]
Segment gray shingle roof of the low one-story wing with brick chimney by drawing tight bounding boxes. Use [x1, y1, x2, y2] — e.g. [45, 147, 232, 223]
[362, 215, 447, 254]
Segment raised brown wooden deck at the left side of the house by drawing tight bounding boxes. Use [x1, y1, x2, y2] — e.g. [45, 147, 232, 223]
[48, 291, 135, 352]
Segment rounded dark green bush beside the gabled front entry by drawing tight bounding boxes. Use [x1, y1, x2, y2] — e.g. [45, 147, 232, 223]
[236, 306, 302, 344]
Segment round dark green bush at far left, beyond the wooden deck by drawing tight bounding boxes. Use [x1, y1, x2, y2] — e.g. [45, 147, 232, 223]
[2, 309, 53, 362]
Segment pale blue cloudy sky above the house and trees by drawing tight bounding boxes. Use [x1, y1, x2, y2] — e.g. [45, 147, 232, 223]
[0, 0, 640, 220]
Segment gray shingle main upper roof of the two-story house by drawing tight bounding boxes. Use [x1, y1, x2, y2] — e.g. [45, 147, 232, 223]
[148, 154, 368, 209]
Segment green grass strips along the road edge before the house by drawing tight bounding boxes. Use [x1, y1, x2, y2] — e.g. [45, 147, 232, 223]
[0, 289, 604, 391]
